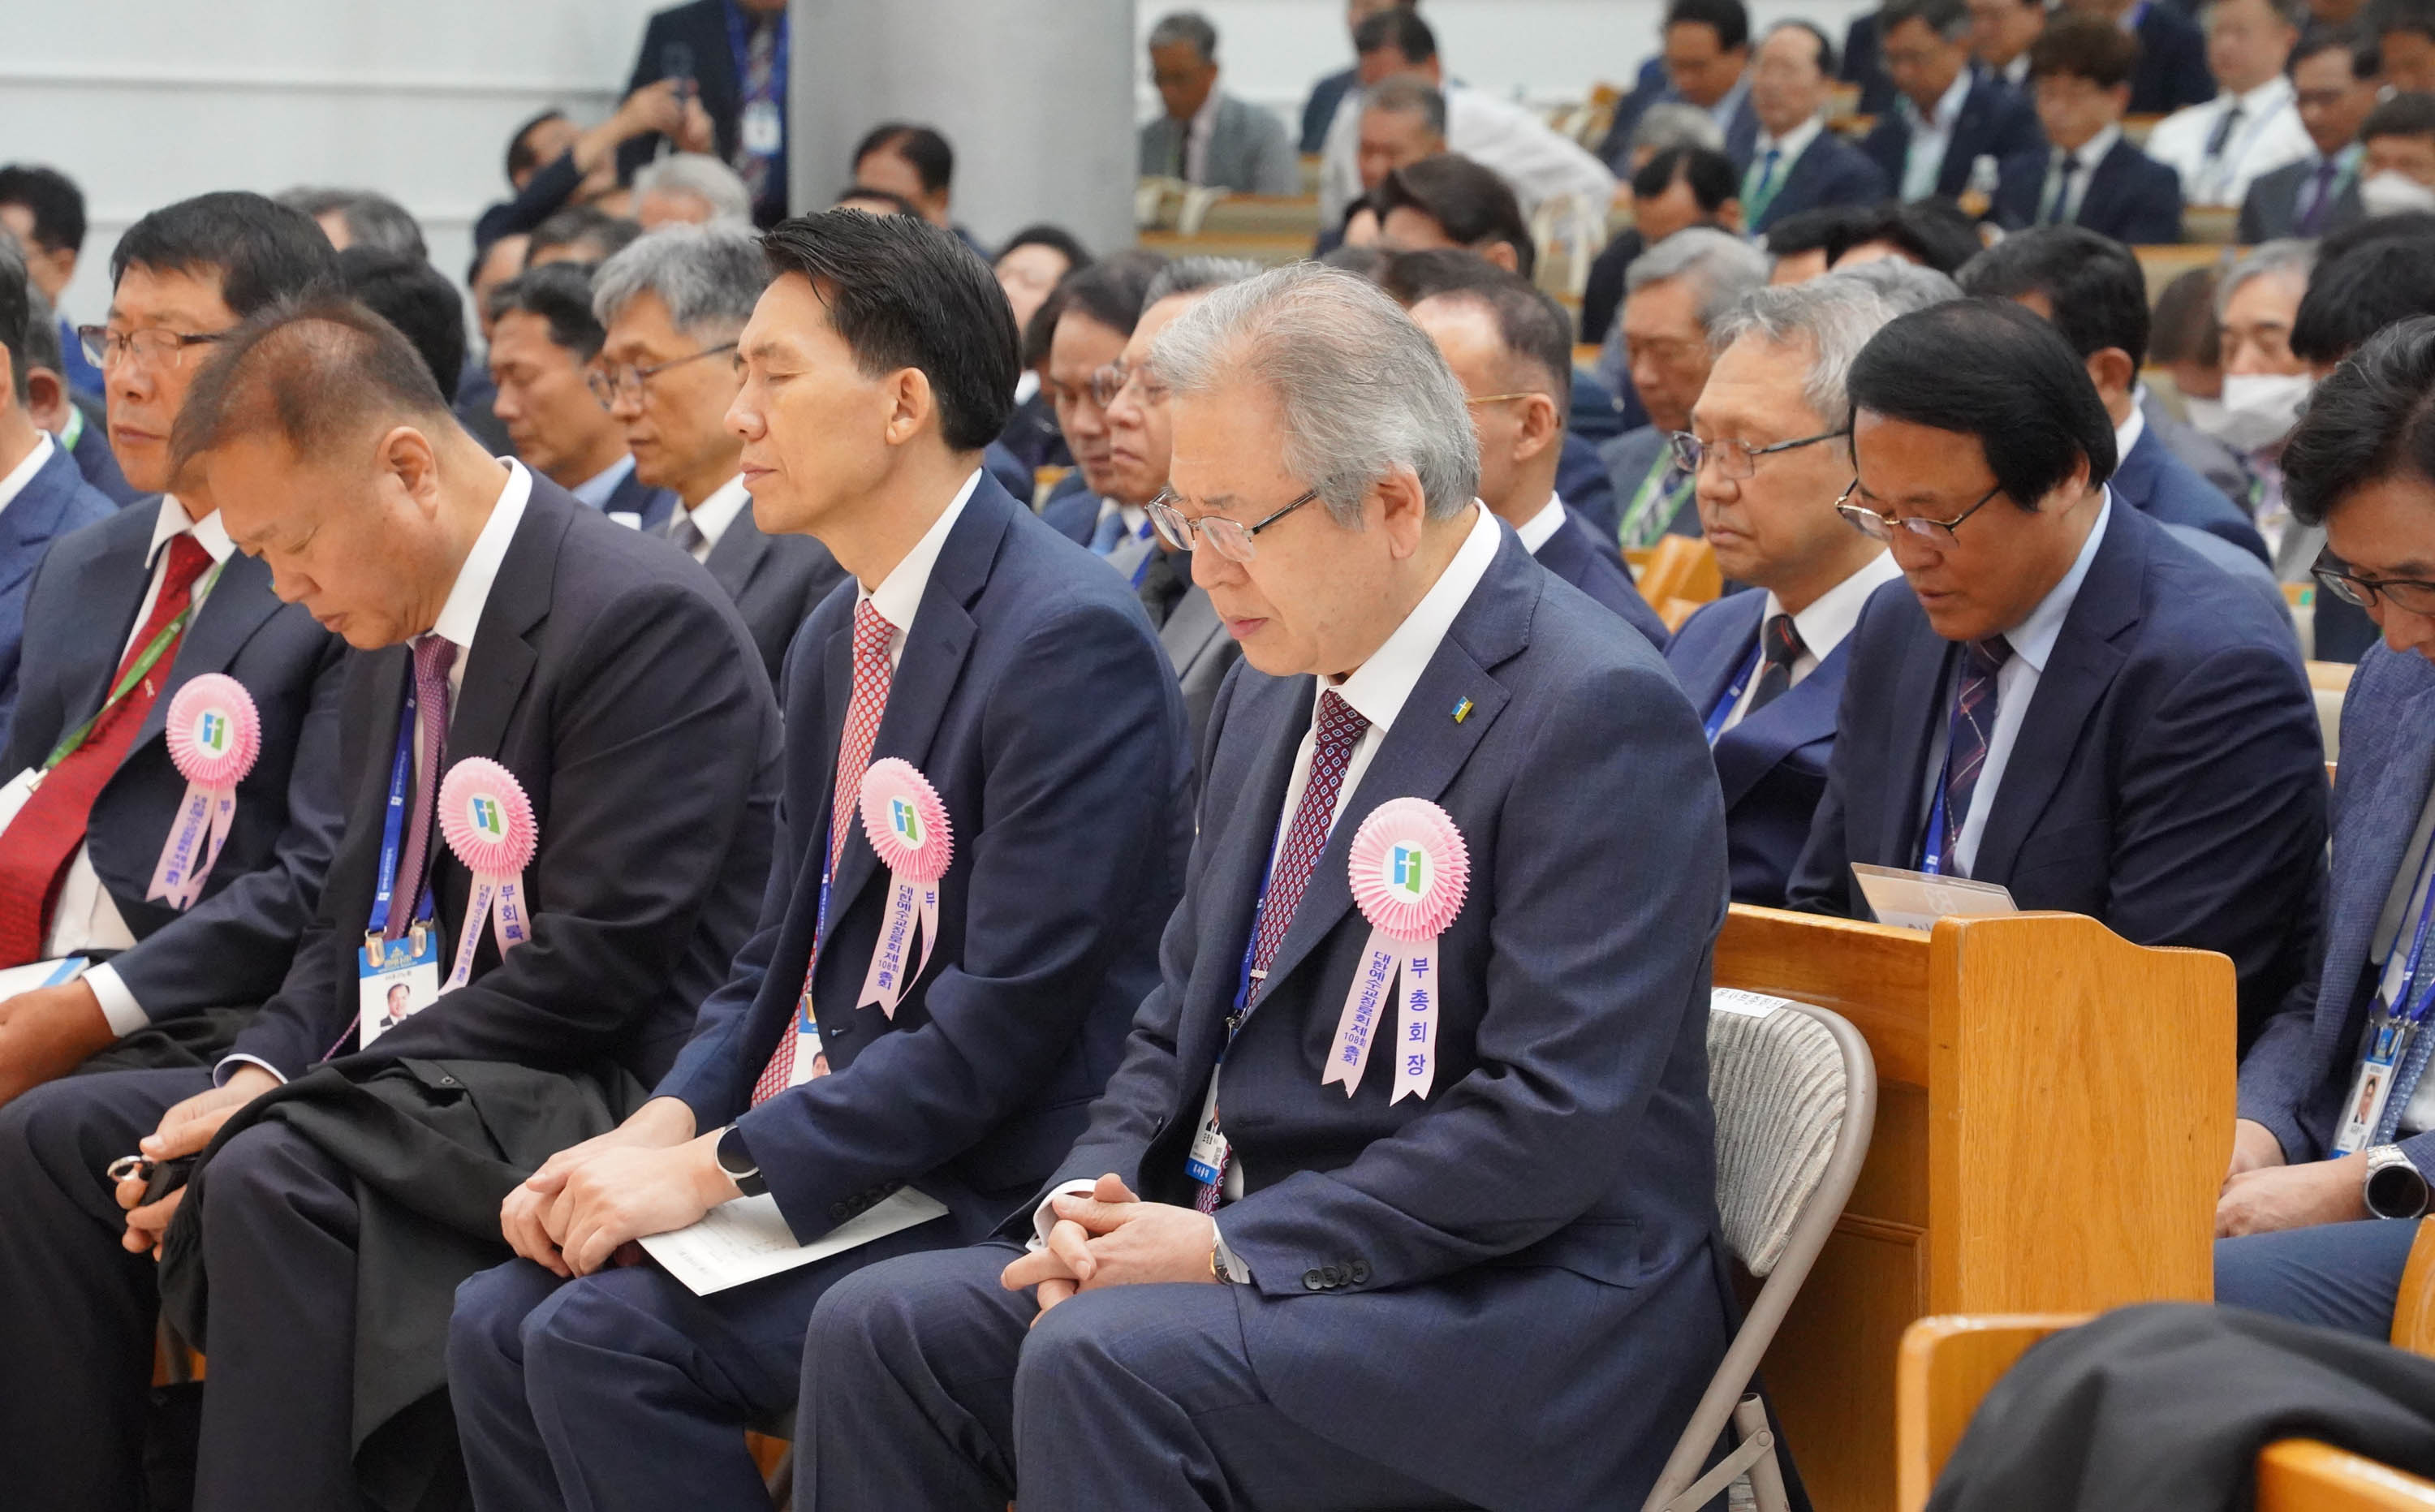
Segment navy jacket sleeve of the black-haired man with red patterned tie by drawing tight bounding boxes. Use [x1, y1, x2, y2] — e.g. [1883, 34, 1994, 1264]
[735, 604, 1183, 1237]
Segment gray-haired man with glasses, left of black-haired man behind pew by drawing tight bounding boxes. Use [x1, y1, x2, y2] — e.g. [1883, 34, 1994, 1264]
[1666, 273, 1902, 908]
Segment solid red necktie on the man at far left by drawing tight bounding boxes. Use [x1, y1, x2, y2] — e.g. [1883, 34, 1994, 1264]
[0, 536, 212, 967]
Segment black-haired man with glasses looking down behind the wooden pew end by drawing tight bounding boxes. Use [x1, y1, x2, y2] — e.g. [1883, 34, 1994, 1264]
[1790, 299, 2325, 1045]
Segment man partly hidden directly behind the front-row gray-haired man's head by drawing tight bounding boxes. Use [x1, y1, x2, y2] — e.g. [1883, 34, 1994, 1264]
[1412, 268, 1666, 650]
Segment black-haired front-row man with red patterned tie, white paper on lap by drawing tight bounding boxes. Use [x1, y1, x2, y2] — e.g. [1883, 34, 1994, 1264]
[448, 212, 1191, 1512]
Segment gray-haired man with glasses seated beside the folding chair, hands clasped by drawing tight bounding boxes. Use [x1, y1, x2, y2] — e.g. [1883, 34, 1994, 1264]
[796, 265, 1729, 1512]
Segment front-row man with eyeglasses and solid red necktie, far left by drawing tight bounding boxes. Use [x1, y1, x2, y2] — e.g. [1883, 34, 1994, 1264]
[0, 192, 346, 1115]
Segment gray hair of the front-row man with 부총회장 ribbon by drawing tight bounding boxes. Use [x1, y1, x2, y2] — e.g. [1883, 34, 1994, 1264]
[1152, 263, 1480, 528]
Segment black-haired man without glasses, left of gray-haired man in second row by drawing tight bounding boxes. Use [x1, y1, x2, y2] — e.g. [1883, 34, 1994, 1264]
[489, 263, 677, 533]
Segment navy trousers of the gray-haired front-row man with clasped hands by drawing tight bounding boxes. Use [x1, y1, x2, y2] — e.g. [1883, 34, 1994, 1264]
[796, 1244, 1463, 1512]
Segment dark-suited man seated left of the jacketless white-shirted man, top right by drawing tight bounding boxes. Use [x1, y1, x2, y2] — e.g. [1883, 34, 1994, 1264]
[1994, 15, 2182, 246]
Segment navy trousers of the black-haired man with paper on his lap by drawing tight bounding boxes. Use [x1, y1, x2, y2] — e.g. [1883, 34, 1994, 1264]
[448, 1217, 955, 1512]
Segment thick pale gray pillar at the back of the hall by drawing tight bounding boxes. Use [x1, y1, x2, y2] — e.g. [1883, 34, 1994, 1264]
[789, 0, 1147, 253]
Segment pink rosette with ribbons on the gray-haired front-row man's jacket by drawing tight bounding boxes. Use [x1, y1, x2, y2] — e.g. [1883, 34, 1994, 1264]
[1320, 799, 1471, 1103]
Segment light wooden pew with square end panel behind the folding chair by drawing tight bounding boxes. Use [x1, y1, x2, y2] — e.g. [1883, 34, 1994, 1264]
[1717, 906, 2233, 1512]
